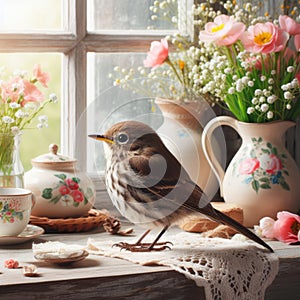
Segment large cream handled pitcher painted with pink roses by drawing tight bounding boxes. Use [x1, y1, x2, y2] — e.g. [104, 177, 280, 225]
[202, 116, 300, 227]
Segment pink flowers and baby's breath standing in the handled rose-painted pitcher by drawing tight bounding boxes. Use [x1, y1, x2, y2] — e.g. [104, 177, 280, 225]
[199, 6, 300, 123]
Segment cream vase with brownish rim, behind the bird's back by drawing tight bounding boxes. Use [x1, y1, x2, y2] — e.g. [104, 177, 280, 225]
[155, 98, 220, 199]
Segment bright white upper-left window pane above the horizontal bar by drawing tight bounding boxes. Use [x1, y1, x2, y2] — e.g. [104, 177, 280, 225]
[0, 0, 63, 32]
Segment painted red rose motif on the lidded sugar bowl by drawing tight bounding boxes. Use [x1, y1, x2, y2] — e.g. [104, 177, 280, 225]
[42, 174, 93, 207]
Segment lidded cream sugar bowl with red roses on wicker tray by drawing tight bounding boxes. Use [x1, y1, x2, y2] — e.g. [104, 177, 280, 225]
[24, 144, 95, 218]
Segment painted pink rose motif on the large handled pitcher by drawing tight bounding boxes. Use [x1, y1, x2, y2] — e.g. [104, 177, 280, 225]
[233, 138, 290, 193]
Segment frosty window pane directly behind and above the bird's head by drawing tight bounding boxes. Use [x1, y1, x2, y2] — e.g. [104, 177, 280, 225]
[85, 53, 162, 173]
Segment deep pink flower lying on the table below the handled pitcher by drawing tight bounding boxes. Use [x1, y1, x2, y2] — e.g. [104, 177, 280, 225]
[273, 211, 300, 244]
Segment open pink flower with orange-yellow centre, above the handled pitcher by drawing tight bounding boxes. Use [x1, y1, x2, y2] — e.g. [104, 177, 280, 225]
[241, 22, 289, 54]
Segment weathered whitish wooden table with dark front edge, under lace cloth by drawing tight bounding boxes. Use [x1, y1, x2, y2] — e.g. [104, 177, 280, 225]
[0, 228, 300, 300]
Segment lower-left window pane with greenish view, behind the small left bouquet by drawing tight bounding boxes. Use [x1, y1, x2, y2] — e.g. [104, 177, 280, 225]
[0, 53, 61, 170]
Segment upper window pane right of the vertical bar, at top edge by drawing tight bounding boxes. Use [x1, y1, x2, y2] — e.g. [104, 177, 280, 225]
[87, 0, 177, 30]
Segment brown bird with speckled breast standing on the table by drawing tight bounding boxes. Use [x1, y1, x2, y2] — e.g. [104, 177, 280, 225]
[89, 120, 273, 252]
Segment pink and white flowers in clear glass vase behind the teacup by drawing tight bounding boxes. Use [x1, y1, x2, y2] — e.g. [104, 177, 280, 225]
[0, 64, 57, 186]
